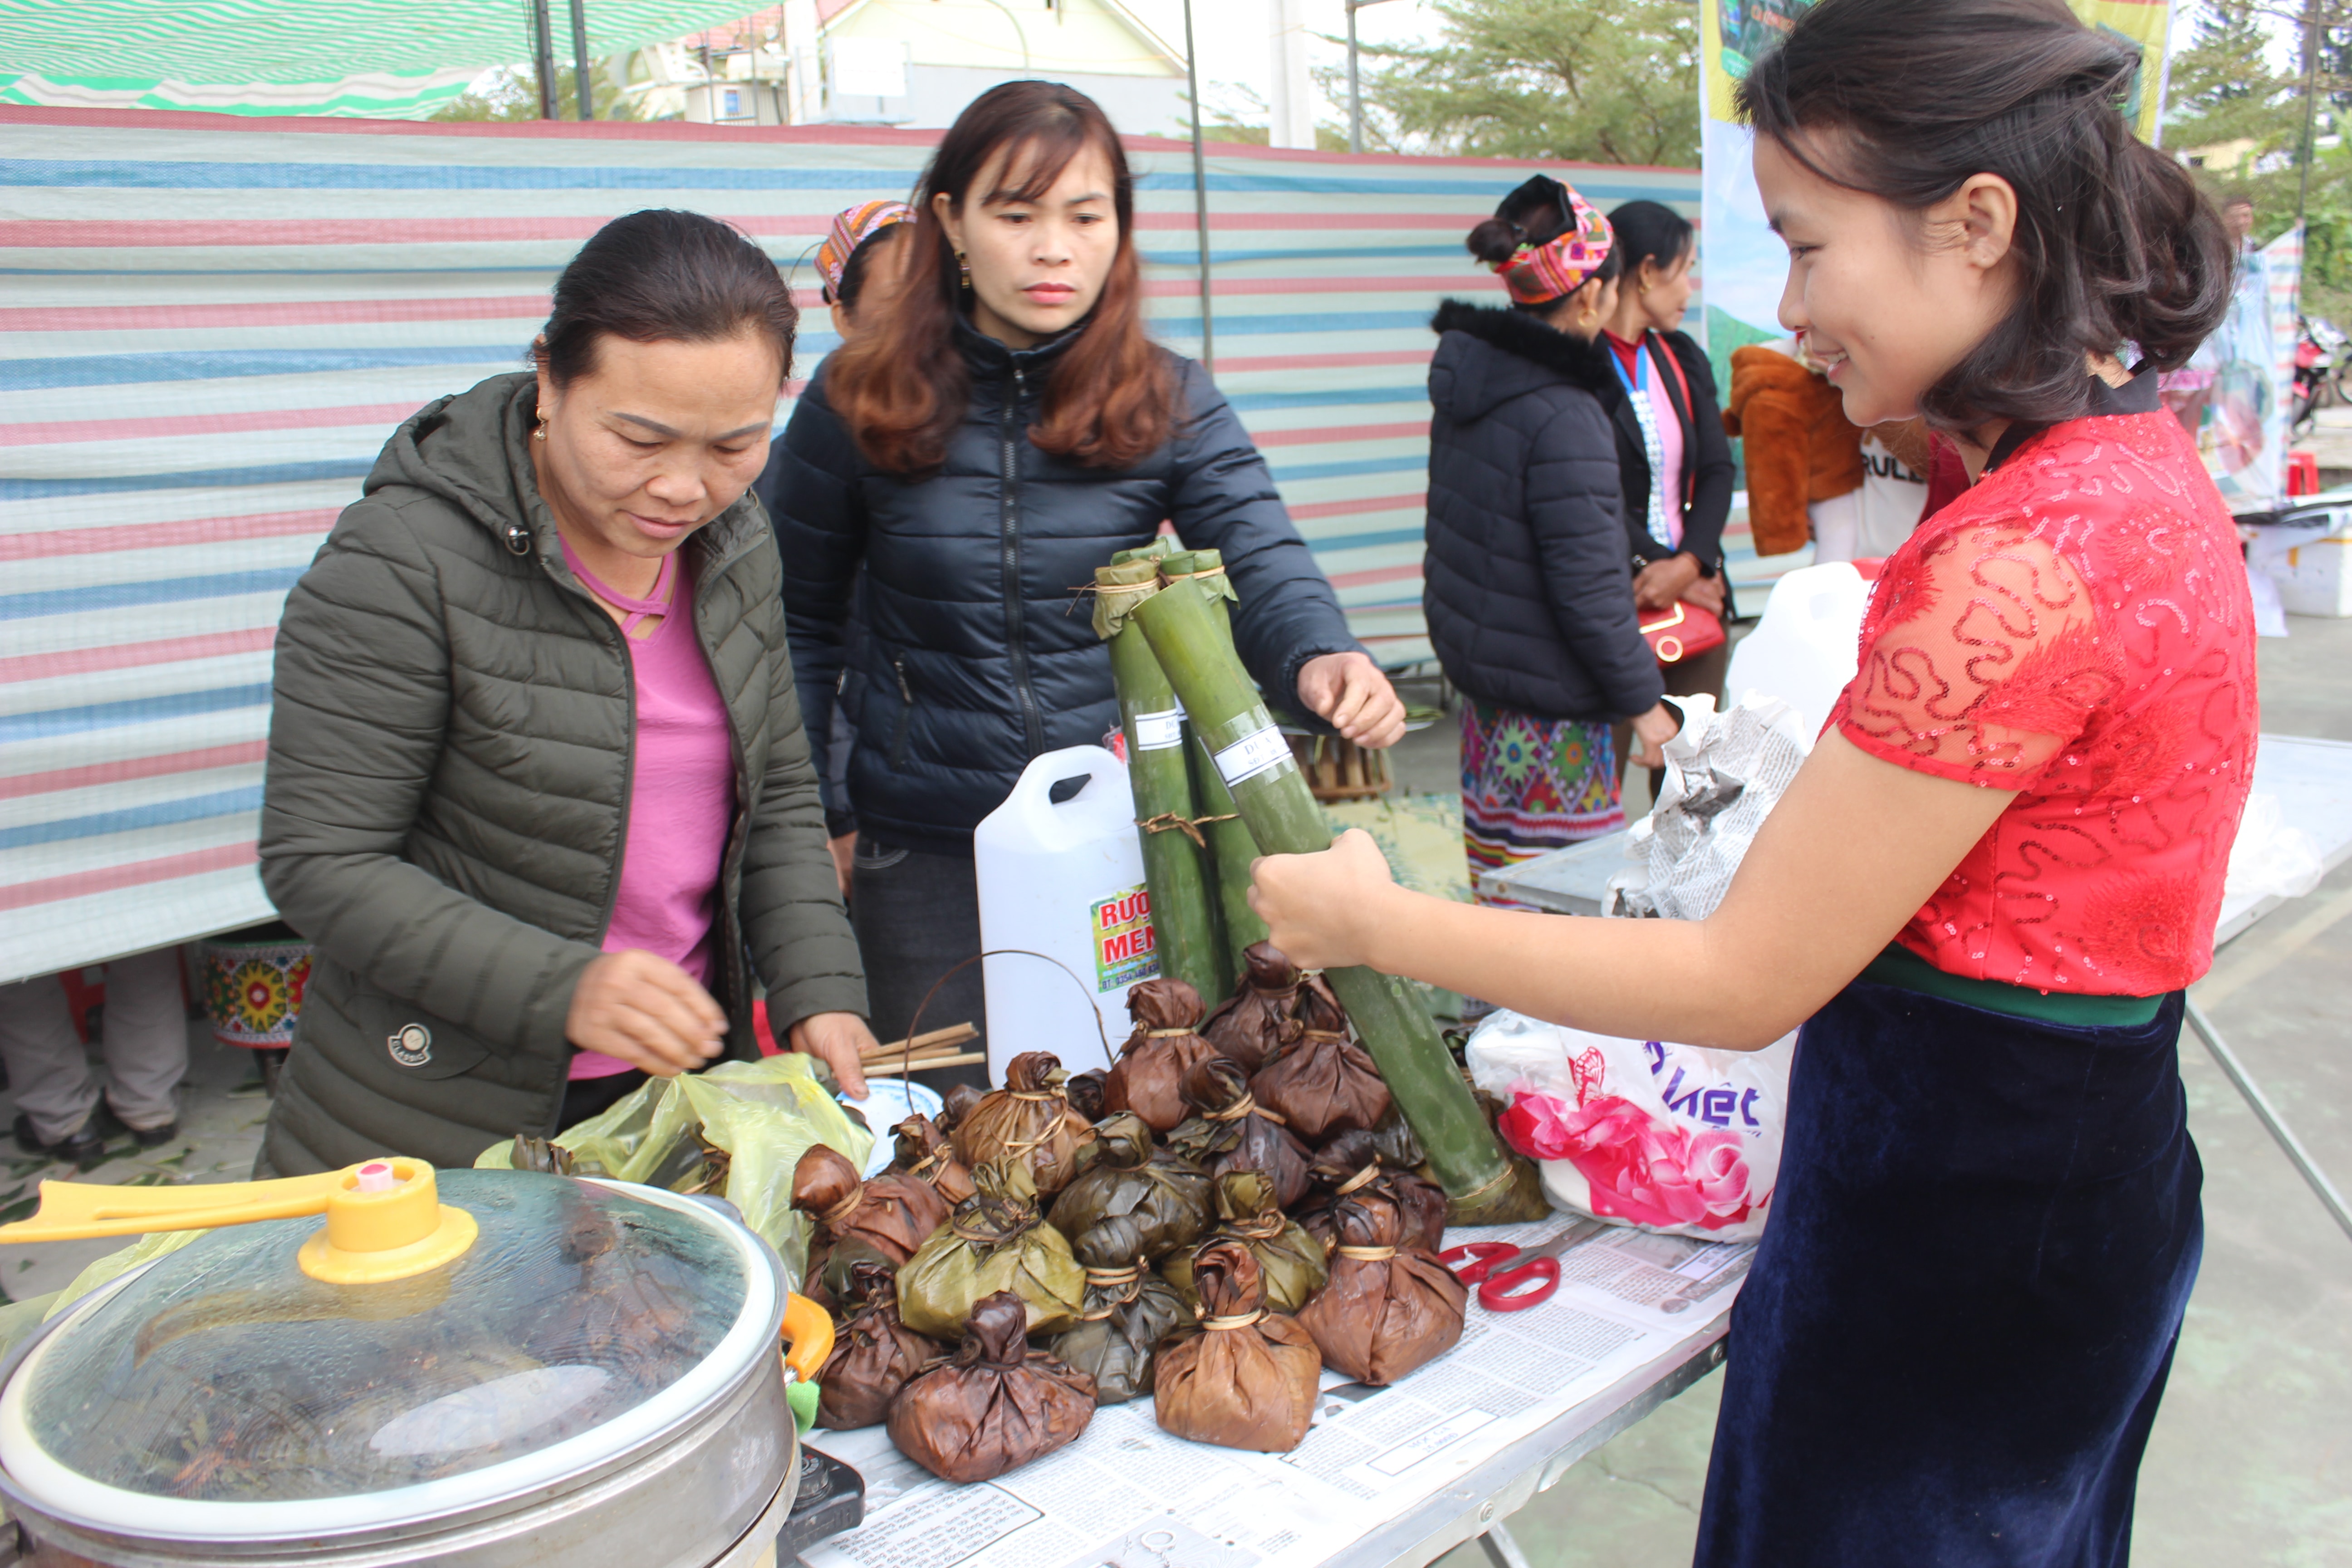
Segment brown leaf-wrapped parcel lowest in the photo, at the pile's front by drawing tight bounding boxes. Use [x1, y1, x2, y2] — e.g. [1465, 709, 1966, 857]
[889, 1291, 1094, 1483]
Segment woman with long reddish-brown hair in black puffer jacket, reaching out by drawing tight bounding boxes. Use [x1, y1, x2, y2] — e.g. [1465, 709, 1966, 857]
[762, 82, 1404, 1067]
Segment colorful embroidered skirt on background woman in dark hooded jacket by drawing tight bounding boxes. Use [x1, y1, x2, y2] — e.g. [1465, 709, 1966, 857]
[1463, 698, 1625, 903]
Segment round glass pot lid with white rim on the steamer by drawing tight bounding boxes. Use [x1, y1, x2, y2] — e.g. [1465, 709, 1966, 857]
[0, 1171, 781, 1540]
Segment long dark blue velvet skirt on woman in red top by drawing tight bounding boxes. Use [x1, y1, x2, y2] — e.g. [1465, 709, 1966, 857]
[1698, 983, 2204, 1568]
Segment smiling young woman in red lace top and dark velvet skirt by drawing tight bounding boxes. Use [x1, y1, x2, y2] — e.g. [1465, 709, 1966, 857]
[1254, 0, 2255, 1568]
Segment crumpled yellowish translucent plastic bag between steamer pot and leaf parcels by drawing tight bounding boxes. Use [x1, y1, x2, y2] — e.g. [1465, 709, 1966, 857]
[473, 1051, 875, 1288]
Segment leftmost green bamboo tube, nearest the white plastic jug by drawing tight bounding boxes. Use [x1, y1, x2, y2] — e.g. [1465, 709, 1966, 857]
[1094, 548, 1232, 1006]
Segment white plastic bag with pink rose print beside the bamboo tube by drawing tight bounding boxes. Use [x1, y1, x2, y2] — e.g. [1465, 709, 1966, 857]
[1465, 1013, 1797, 1241]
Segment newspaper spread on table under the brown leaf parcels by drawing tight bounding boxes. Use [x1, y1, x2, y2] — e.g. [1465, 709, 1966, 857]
[802, 1215, 1754, 1568]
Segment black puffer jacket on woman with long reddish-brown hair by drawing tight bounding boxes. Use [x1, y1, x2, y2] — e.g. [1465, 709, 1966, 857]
[760, 324, 1362, 853]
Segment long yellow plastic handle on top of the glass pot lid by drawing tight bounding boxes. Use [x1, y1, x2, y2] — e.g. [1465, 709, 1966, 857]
[0, 1159, 477, 1284]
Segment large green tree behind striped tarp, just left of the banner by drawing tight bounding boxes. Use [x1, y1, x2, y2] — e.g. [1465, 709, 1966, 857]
[1322, 0, 1698, 167]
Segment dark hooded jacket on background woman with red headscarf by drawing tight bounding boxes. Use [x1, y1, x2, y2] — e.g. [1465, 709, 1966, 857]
[1421, 301, 1665, 722]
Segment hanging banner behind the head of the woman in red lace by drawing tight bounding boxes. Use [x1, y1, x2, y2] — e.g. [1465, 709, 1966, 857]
[1698, 0, 2171, 373]
